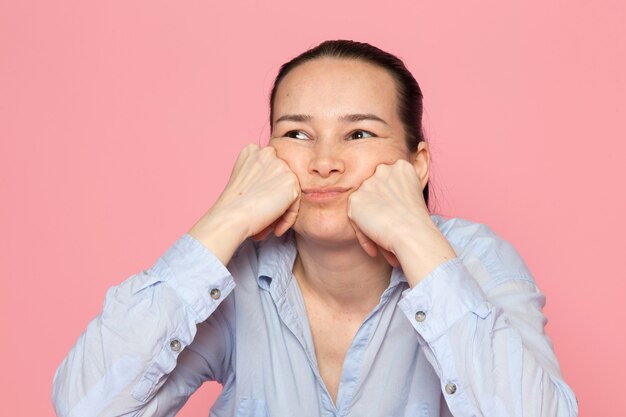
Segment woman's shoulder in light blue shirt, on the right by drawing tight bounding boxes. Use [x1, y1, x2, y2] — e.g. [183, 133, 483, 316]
[431, 215, 534, 288]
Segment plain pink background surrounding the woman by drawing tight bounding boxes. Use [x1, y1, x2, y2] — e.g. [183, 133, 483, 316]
[0, 0, 626, 417]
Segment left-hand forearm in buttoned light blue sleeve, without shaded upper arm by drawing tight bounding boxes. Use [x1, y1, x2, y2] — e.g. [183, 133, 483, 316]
[53, 236, 234, 416]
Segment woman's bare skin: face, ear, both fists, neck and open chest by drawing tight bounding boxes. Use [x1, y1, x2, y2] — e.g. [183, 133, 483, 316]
[189, 58, 456, 401]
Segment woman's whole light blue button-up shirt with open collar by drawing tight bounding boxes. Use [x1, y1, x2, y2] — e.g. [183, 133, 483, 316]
[53, 216, 578, 417]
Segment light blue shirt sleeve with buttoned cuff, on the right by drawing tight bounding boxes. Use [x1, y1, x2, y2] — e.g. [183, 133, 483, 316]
[399, 226, 578, 417]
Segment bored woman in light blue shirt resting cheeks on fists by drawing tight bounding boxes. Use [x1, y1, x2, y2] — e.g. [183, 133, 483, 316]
[54, 41, 577, 417]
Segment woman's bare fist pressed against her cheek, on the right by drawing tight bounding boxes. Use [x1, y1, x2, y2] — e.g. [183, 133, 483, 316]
[348, 160, 456, 285]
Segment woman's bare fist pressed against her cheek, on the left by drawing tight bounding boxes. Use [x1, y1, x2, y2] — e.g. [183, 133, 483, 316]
[189, 144, 300, 264]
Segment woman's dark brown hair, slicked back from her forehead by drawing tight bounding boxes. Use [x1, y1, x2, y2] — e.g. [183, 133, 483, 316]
[270, 40, 429, 205]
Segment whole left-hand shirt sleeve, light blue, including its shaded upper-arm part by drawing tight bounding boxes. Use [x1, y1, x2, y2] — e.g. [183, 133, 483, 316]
[53, 234, 235, 417]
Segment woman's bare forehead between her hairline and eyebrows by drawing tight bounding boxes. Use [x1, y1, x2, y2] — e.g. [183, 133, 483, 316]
[274, 58, 397, 122]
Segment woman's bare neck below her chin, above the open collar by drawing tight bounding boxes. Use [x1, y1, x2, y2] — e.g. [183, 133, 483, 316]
[293, 235, 391, 313]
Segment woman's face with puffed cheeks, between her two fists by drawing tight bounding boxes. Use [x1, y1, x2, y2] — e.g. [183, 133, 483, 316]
[270, 58, 420, 243]
